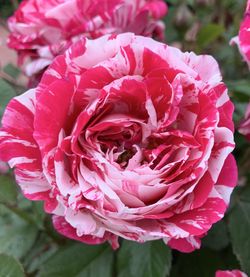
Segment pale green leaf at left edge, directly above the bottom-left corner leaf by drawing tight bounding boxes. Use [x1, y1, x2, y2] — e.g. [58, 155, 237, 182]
[0, 205, 37, 258]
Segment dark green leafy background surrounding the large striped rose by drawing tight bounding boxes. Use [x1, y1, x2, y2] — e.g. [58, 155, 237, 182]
[0, 0, 250, 277]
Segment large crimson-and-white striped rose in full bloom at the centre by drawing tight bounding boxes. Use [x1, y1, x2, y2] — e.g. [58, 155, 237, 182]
[0, 33, 237, 252]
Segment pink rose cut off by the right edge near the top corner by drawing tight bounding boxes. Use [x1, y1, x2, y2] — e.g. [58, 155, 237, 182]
[230, 0, 250, 67]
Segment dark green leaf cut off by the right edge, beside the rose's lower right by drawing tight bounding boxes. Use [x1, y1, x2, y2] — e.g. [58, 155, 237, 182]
[229, 187, 250, 274]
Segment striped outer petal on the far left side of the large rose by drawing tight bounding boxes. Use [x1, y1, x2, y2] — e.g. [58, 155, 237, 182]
[0, 90, 51, 208]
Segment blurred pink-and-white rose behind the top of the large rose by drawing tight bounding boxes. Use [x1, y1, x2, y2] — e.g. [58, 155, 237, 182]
[8, 0, 167, 80]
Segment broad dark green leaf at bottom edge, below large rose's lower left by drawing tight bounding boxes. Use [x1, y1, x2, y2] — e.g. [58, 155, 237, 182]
[38, 243, 113, 277]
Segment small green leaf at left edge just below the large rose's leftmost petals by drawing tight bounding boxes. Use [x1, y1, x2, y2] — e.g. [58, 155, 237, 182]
[0, 175, 17, 204]
